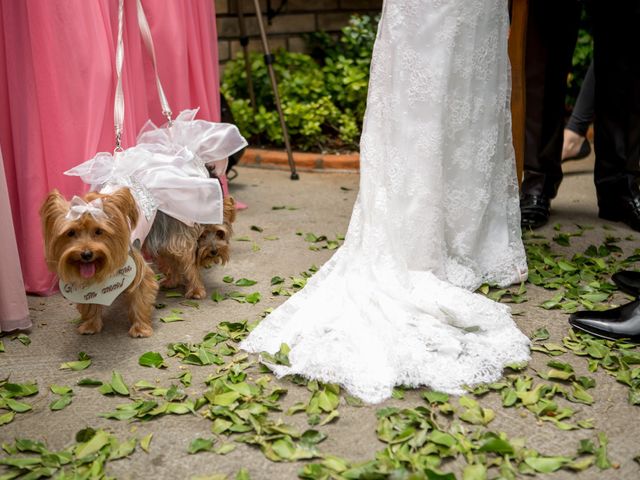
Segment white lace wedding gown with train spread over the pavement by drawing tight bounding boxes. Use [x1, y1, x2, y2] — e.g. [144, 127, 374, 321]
[241, 0, 529, 403]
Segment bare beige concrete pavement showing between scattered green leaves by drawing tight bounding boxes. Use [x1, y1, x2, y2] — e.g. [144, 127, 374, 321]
[0, 158, 640, 480]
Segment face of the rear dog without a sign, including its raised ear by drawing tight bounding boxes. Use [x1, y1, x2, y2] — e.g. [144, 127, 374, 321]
[196, 197, 236, 268]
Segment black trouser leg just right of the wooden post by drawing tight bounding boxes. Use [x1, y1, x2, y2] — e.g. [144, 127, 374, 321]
[522, 0, 584, 198]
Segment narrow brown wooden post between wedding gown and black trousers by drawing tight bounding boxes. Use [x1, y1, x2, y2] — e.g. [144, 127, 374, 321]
[509, 0, 529, 188]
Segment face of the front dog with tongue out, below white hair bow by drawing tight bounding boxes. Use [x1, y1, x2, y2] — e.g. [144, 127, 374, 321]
[40, 188, 138, 285]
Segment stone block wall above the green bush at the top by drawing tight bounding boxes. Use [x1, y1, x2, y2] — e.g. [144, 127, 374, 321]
[215, 0, 382, 65]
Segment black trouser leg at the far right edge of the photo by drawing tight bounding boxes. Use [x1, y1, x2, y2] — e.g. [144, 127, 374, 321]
[593, 0, 640, 202]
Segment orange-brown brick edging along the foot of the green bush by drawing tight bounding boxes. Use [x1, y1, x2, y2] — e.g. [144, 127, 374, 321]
[240, 148, 360, 172]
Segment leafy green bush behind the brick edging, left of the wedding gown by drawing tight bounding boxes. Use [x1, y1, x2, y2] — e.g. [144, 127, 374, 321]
[221, 16, 377, 151]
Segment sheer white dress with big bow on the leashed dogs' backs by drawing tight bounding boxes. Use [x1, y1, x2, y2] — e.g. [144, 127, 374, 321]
[64, 109, 247, 242]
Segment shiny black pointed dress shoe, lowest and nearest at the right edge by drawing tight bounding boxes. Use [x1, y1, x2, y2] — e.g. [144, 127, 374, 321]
[569, 300, 640, 343]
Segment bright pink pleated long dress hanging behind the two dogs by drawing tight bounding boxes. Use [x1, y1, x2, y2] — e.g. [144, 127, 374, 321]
[0, 0, 220, 295]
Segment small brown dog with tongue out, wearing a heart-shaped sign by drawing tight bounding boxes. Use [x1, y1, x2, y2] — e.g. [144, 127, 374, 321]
[40, 188, 158, 337]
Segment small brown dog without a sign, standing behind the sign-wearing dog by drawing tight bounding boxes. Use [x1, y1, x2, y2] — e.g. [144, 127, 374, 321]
[142, 197, 236, 299]
